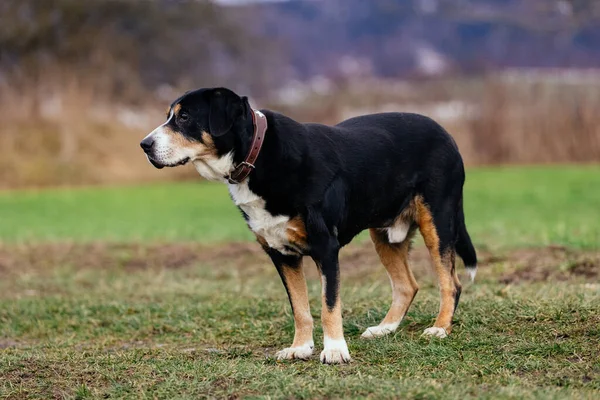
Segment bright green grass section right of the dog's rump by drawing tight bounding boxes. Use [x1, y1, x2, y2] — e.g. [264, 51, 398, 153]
[465, 166, 600, 248]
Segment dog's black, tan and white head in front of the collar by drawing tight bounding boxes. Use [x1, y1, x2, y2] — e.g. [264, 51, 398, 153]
[140, 88, 250, 180]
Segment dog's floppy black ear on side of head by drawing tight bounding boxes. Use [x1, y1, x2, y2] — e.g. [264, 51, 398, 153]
[208, 88, 243, 136]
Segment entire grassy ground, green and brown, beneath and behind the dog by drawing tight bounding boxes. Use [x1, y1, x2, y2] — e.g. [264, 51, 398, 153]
[0, 167, 600, 399]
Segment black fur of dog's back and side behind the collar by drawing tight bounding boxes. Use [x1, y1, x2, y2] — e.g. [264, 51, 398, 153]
[249, 110, 464, 245]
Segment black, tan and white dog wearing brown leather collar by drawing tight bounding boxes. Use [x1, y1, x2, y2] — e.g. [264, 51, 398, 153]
[141, 88, 477, 364]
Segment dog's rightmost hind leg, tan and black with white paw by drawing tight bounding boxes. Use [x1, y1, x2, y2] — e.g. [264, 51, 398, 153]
[415, 197, 461, 338]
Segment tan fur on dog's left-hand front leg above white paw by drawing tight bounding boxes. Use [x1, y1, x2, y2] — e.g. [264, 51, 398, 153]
[282, 262, 313, 347]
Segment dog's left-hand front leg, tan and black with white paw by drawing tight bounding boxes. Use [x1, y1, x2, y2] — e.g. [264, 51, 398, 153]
[268, 251, 314, 360]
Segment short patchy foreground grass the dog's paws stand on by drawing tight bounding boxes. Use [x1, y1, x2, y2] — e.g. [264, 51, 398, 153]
[0, 248, 600, 399]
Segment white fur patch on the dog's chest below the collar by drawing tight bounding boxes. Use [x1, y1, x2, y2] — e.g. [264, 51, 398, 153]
[228, 180, 292, 254]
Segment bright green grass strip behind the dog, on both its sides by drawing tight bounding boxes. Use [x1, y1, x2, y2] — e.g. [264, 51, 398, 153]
[0, 166, 600, 248]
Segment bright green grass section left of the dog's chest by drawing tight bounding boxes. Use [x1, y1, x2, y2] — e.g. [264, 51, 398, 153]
[0, 182, 251, 242]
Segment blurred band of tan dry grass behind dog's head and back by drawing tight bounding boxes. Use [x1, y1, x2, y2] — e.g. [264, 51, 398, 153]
[0, 71, 600, 188]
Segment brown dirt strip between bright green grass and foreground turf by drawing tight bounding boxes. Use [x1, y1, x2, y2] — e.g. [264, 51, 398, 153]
[0, 242, 600, 284]
